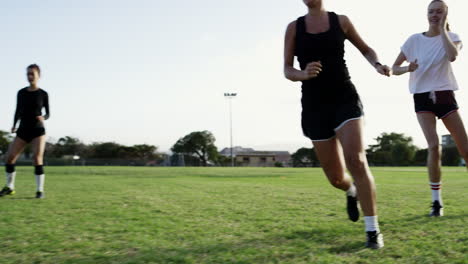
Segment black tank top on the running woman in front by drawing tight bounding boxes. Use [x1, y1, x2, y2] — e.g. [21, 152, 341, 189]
[295, 12, 350, 94]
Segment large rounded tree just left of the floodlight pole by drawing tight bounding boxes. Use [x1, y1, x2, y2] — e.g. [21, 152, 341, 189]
[171, 131, 218, 166]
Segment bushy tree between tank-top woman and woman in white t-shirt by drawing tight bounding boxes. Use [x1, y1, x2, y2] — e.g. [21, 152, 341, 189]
[367, 133, 417, 166]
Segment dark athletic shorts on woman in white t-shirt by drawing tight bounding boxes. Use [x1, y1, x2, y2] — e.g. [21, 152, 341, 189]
[413, 90, 458, 119]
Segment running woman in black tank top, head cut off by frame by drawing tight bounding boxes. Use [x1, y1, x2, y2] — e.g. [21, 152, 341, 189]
[284, 0, 391, 249]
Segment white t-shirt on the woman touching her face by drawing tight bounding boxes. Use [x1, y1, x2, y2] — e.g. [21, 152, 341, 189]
[401, 32, 461, 94]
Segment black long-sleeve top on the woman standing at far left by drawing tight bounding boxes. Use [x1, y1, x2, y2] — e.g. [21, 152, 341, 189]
[13, 87, 50, 128]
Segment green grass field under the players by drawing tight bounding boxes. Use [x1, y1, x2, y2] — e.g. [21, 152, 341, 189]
[0, 167, 468, 264]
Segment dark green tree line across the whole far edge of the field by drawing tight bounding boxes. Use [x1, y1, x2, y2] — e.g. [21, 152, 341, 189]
[0, 130, 460, 167]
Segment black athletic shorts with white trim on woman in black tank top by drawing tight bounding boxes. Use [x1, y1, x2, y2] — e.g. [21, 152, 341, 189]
[301, 81, 364, 141]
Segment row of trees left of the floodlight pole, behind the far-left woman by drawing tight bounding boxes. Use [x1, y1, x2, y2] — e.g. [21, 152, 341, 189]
[0, 130, 229, 166]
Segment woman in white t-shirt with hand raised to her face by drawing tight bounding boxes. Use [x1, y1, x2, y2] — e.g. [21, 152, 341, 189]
[393, 0, 468, 216]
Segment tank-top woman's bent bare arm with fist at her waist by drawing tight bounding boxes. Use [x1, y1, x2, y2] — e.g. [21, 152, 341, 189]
[283, 21, 322, 82]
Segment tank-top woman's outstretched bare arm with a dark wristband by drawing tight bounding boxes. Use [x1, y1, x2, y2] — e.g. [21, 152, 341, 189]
[339, 15, 391, 76]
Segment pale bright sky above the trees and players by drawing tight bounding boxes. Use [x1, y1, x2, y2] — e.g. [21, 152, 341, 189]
[0, 0, 468, 152]
